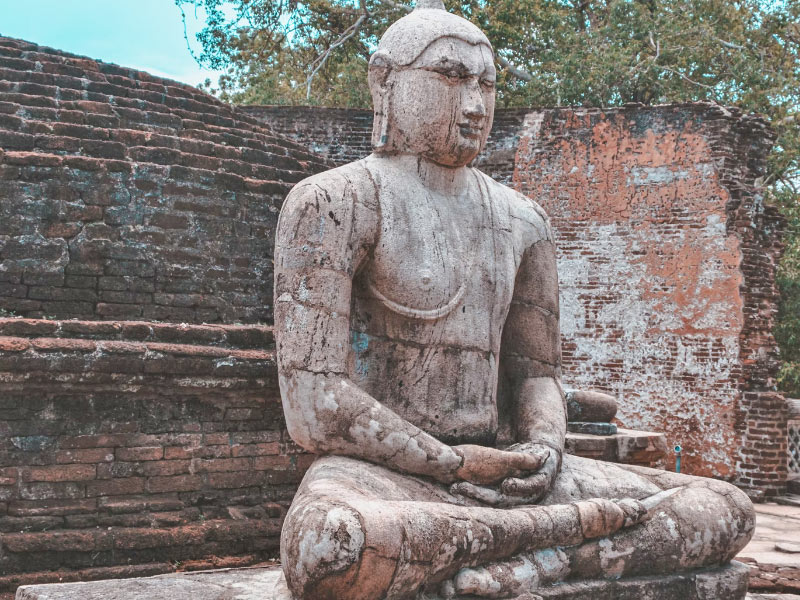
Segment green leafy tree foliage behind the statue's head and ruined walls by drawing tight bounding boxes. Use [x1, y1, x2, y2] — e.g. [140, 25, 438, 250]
[175, 0, 800, 395]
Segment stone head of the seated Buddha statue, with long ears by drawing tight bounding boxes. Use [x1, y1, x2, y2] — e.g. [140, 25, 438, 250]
[369, 0, 496, 167]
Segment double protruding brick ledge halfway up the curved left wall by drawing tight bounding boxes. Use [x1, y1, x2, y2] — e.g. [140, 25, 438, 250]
[0, 318, 277, 387]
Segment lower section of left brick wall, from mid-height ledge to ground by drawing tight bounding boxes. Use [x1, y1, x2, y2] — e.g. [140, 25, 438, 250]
[0, 319, 304, 594]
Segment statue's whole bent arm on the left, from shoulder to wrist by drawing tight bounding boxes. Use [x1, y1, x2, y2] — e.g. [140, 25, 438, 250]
[275, 170, 462, 482]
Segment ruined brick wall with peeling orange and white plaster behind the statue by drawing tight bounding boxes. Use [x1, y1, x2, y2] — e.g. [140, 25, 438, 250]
[514, 104, 786, 495]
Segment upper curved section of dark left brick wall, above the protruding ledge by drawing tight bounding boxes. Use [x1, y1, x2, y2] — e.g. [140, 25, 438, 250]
[0, 38, 327, 323]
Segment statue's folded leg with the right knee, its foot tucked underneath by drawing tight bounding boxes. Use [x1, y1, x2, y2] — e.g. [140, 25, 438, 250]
[453, 456, 755, 598]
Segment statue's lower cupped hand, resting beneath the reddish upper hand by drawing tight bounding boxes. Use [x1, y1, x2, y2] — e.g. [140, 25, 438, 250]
[450, 442, 561, 506]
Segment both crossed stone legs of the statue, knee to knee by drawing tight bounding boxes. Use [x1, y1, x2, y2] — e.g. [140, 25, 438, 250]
[281, 456, 754, 600]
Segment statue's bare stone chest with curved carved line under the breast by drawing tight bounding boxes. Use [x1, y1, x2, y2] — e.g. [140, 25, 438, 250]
[364, 180, 517, 335]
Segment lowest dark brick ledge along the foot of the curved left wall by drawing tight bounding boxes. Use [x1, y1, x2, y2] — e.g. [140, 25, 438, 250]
[0, 519, 280, 592]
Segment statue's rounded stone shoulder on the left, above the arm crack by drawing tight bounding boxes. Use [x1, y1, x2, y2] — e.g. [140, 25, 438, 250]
[275, 161, 378, 276]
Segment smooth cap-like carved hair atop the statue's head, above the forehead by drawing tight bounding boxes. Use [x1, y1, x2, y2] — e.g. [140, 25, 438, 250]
[370, 0, 492, 67]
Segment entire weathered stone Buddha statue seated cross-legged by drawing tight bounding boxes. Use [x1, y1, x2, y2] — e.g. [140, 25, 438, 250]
[275, 0, 754, 600]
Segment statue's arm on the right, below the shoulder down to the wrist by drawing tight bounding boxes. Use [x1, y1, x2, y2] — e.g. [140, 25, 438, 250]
[500, 226, 567, 470]
